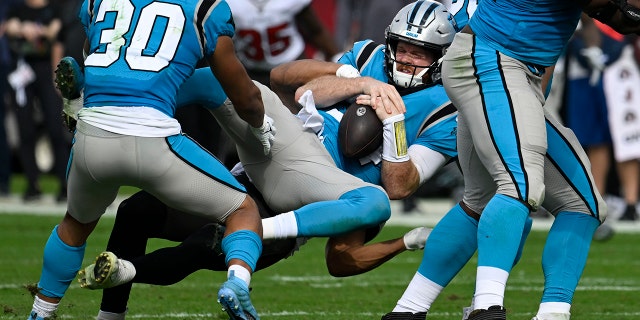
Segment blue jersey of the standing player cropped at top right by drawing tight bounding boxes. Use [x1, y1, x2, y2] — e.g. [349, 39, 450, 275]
[469, 0, 582, 66]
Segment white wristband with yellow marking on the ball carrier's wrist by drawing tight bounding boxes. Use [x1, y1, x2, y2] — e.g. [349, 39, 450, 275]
[382, 114, 411, 162]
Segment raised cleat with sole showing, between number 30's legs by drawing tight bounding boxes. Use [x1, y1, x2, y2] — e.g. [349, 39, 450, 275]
[78, 251, 136, 289]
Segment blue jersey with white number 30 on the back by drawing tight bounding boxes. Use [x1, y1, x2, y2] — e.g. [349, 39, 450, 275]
[79, 0, 234, 117]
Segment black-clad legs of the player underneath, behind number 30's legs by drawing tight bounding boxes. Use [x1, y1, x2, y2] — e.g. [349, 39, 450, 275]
[85, 180, 296, 320]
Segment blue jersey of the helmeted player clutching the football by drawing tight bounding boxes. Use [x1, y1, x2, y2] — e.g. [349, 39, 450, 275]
[320, 40, 457, 185]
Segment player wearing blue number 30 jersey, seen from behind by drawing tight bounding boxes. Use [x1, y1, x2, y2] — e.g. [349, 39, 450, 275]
[28, 0, 275, 320]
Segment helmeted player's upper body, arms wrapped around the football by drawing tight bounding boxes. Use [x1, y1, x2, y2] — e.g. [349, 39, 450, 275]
[263, 1, 457, 275]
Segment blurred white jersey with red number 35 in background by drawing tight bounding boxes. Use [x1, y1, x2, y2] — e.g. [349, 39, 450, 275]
[228, 0, 311, 71]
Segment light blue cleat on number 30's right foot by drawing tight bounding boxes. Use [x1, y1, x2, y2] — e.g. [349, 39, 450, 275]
[218, 271, 260, 320]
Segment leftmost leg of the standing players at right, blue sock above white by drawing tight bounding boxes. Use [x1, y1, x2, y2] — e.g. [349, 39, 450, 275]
[383, 118, 496, 319]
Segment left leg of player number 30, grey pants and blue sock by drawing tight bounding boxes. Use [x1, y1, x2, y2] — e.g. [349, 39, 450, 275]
[32, 121, 118, 319]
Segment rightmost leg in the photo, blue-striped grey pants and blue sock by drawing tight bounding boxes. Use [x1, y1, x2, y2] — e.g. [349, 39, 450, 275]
[534, 111, 607, 320]
